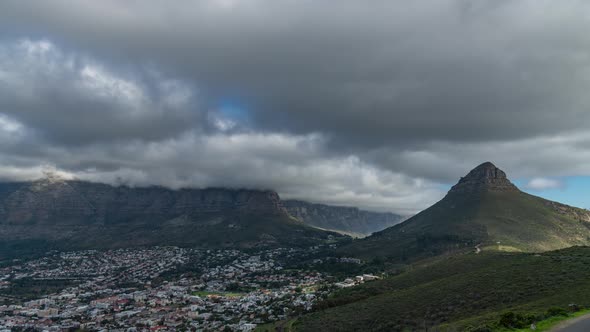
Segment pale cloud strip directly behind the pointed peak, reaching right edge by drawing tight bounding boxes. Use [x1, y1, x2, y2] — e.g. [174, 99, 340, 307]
[363, 131, 590, 184]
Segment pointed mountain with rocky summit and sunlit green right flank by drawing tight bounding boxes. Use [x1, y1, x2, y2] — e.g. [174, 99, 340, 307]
[342, 162, 590, 261]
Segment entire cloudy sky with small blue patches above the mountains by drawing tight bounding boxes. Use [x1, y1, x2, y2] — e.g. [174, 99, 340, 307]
[0, 0, 590, 214]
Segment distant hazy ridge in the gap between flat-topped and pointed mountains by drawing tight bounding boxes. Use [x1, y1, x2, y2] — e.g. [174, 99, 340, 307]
[283, 200, 404, 237]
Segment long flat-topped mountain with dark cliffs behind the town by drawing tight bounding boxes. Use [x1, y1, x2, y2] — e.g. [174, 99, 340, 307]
[0, 177, 334, 256]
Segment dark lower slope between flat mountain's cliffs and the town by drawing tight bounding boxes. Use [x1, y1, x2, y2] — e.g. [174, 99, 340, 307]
[0, 214, 345, 263]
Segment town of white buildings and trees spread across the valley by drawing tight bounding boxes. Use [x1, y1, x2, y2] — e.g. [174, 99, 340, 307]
[0, 247, 376, 331]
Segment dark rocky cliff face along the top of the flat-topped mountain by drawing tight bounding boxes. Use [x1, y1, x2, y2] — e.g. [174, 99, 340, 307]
[0, 179, 286, 225]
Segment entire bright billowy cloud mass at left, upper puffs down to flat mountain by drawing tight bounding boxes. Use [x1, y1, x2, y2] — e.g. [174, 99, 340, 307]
[0, 39, 441, 214]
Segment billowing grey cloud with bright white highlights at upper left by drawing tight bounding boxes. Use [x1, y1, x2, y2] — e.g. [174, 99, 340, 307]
[0, 39, 203, 145]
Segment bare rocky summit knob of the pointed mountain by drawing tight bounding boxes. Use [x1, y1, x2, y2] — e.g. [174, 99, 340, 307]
[450, 161, 518, 193]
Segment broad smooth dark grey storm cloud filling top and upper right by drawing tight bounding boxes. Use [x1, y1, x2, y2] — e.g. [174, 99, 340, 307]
[2, 0, 590, 148]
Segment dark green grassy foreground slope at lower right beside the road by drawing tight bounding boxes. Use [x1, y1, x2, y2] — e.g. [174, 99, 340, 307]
[295, 247, 590, 331]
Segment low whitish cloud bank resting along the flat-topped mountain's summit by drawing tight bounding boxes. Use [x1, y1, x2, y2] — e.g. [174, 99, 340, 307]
[0, 128, 441, 215]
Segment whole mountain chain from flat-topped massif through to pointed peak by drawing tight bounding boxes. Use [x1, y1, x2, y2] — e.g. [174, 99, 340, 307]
[0, 163, 590, 261]
